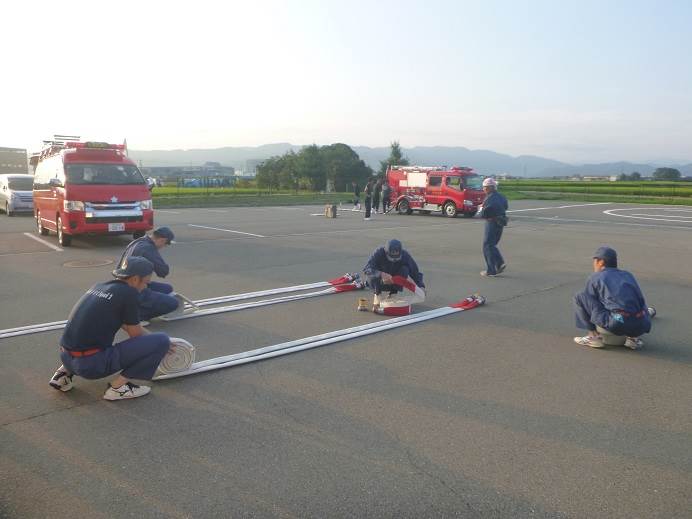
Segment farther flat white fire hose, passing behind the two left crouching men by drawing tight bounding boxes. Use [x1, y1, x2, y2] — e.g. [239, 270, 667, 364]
[0, 274, 358, 339]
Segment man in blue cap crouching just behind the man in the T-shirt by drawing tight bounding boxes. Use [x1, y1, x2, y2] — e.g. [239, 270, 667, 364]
[118, 227, 179, 321]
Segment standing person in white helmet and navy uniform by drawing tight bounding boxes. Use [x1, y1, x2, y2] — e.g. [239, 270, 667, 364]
[478, 177, 508, 277]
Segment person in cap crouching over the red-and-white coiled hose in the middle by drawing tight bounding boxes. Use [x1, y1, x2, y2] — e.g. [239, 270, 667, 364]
[363, 240, 425, 296]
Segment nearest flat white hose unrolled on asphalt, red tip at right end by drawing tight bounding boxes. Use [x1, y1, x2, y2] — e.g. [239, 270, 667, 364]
[154, 295, 485, 380]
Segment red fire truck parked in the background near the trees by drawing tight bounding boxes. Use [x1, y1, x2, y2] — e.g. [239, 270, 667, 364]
[386, 166, 485, 218]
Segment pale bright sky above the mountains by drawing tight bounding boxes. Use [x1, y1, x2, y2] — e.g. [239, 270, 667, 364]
[0, 0, 692, 163]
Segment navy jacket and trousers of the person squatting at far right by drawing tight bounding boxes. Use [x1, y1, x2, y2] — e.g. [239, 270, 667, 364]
[574, 267, 651, 337]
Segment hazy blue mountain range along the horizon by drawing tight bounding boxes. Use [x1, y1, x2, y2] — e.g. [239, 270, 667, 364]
[129, 143, 692, 177]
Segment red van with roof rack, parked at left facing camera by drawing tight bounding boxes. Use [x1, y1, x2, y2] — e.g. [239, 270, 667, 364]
[31, 141, 154, 246]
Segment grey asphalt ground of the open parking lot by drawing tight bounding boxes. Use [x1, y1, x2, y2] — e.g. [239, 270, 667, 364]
[0, 201, 692, 518]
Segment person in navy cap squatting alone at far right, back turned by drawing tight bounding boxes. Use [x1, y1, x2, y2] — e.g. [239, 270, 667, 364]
[574, 246, 656, 350]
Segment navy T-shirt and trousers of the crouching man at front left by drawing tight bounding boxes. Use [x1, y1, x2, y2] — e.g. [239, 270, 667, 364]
[60, 272, 170, 380]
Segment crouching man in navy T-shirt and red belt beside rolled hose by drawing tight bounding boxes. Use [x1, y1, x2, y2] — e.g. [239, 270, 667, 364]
[50, 256, 170, 400]
